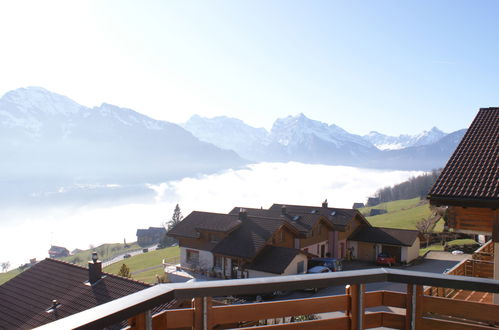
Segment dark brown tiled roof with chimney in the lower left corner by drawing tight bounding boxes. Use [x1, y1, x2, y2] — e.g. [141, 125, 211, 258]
[0, 259, 150, 329]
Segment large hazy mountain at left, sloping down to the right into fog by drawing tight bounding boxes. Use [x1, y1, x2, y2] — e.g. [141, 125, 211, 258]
[0, 87, 247, 183]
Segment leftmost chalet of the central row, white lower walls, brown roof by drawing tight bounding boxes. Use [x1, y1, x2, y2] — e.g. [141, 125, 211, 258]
[168, 210, 307, 278]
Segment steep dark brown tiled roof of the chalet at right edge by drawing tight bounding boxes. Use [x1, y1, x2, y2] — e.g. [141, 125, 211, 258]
[428, 108, 499, 207]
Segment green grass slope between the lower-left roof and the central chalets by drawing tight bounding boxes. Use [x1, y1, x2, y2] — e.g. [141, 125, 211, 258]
[104, 246, 180, 283]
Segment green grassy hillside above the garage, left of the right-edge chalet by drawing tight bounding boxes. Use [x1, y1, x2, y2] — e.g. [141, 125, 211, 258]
[359, 198, 443, 232]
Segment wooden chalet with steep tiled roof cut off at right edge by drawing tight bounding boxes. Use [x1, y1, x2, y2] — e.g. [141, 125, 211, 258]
[428, 108, 499, 304]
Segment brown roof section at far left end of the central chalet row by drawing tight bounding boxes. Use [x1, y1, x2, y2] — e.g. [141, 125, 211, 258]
[168, 211, 241, 238]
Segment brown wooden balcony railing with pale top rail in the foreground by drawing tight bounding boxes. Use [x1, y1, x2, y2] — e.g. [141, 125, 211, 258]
[35, 268, 499, 330]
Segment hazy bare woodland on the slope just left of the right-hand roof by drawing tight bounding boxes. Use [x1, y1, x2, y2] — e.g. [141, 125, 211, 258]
[375, 170, 441, 203]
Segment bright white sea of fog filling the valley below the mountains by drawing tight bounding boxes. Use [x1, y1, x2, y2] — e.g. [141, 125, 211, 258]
[0, 162, 422, 268]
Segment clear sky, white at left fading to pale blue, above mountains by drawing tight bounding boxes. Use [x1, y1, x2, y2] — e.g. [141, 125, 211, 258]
[0, 0, 499, 135]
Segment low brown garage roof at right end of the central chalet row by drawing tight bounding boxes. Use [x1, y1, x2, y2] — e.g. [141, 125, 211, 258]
[348, 226, 419, 246]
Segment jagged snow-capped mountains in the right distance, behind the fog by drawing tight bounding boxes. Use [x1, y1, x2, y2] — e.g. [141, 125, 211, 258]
[182, 114, 466, 170]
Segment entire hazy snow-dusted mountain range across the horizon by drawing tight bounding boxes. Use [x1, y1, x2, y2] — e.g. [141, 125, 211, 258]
[0, 87, 465, 192]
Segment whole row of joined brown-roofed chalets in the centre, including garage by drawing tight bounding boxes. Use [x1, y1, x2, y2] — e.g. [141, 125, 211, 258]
[172, 201, 419, 278]
